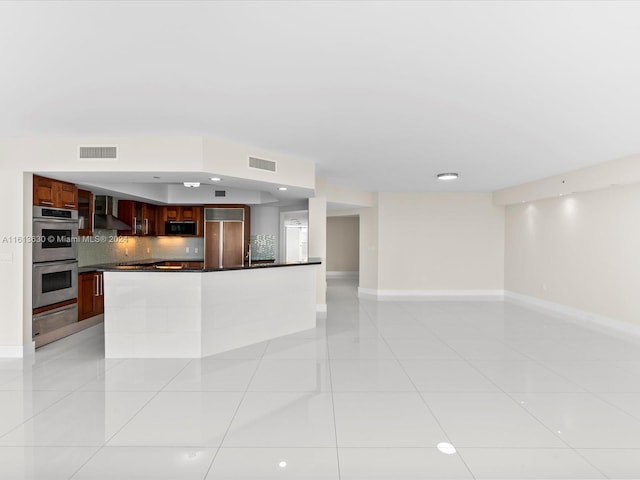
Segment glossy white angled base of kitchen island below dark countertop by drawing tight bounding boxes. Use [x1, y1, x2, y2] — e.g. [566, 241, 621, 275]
[104, 265, 316, 358]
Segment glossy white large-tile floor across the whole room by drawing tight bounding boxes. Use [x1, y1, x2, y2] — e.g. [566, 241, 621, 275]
[0, 280, 640, 480]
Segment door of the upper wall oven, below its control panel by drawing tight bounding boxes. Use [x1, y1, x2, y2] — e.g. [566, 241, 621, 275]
[33, 218, 78, 263]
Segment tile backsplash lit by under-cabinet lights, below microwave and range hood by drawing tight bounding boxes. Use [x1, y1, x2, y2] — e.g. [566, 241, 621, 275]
[78, 229, 204, 267]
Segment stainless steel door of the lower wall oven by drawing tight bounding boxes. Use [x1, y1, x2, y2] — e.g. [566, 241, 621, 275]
[33, 260, 78, 308]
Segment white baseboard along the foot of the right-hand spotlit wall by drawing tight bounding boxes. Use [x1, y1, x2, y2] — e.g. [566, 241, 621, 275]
[504, 290, 640, 337]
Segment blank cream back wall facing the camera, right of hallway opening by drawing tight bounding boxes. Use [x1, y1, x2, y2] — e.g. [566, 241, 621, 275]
[377, 193, 504, 293]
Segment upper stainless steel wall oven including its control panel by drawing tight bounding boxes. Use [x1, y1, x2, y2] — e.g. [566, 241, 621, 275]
[33, 207, 78, 263]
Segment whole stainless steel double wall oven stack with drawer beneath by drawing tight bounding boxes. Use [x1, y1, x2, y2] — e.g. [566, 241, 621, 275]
[33, 206, 78, 346]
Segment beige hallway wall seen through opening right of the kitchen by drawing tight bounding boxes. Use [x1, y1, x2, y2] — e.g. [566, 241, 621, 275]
[327, 216, 360, 272]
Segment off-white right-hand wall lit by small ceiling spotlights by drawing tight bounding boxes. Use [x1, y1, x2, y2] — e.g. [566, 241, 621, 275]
[505, 184, 640, 324]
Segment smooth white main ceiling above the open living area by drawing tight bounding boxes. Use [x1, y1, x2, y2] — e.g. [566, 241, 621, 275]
[0, 1, 640, 191]
